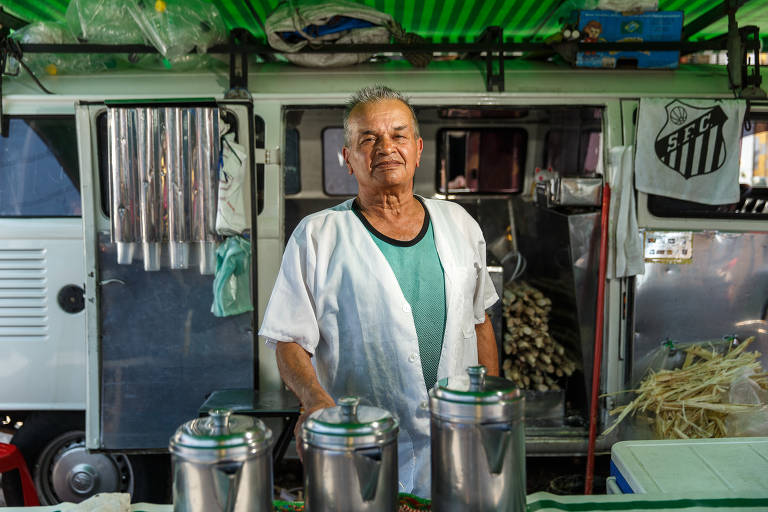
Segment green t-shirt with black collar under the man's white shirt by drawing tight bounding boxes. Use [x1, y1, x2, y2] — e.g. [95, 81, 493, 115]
[352, 197, 446, 390]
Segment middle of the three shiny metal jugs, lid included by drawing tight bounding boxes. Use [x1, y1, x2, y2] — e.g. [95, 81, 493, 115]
[302, 397, 400, 512]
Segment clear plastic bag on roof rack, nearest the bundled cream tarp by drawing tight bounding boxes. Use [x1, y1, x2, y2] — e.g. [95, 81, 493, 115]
[125, 0, 227, 59]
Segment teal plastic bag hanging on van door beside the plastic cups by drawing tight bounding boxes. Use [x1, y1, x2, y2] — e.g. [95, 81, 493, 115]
[211, 236, 253, 317]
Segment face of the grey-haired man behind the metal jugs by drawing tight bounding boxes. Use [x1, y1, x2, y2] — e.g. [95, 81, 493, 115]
[342, 100, 424, 193]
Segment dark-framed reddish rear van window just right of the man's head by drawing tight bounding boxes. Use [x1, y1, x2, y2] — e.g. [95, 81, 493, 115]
[437, 128, 528, 194]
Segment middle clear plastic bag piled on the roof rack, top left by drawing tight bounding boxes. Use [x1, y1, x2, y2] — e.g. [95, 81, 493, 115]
[66, 0, 144, 44]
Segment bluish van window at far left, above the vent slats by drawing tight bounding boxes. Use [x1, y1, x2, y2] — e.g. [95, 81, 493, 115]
[0, 116, 81, 217]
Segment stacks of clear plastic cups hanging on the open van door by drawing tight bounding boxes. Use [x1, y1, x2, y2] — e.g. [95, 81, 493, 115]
[107, 106, 219, 274]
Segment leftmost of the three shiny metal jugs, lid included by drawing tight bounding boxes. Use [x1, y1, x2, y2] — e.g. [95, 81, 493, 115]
[170, 409, 272, 512]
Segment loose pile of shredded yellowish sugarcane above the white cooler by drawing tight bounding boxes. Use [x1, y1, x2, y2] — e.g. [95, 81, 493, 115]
[603, 337, 768, 439]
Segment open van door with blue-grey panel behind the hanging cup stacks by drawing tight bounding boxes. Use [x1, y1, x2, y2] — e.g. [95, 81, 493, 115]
[76, 100, 257, 451]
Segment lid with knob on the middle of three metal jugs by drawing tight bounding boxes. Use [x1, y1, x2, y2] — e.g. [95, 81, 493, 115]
[302, 396, 399, 447]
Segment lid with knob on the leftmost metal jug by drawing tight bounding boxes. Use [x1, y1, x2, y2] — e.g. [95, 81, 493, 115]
[170, 409, 272, 453]
